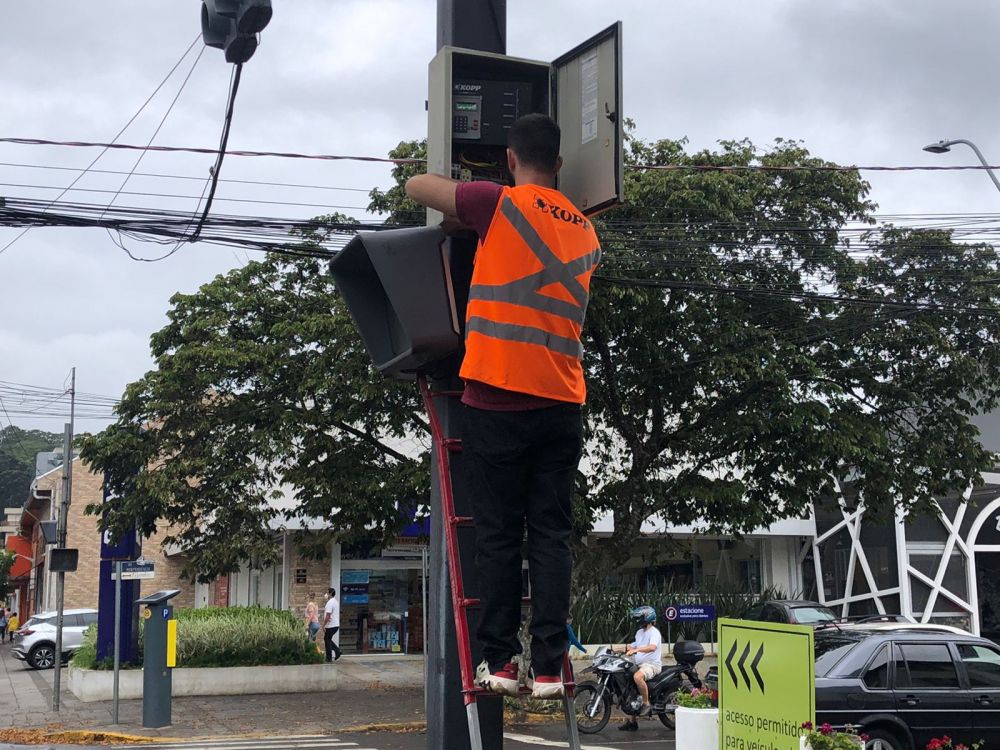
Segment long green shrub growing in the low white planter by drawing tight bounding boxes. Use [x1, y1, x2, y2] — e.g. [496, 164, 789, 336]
[73, 607, 324, 669]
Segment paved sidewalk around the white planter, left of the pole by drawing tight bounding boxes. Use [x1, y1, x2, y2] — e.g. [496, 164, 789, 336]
[0, 644, 424, 738]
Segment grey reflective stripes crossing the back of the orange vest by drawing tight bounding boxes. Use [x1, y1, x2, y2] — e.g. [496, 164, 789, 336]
[466, 195, 601, 359]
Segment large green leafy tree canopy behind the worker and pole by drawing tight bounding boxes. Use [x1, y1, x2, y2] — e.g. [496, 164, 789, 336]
[83, 128, 1000, 579]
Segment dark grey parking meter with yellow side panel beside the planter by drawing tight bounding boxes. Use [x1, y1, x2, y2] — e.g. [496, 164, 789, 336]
[136, 589, 180, 728]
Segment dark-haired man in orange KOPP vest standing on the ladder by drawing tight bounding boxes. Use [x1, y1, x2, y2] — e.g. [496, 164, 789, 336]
[406, 114, 601, 699]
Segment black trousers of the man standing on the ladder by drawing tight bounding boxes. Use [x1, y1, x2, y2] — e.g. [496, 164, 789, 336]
[462, 404, 583, 676]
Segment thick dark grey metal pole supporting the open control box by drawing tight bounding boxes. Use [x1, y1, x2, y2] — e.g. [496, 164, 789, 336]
[426, 5, 507, 750]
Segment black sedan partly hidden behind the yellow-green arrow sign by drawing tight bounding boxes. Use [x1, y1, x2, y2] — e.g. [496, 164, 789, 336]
[705, 623, 1000, 750]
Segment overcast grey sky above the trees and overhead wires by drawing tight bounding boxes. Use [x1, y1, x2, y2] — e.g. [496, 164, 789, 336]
[0, 0, 1000, 430]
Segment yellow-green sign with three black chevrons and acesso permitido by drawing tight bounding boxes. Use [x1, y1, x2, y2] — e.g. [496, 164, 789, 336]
[718, 619, 816, 750]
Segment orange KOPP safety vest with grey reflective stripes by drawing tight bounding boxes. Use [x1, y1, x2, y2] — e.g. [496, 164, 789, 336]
[459, 185, 601, 404]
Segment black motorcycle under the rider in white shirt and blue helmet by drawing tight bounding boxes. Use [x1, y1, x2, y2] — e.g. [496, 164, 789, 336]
[573, 641, 705, 734]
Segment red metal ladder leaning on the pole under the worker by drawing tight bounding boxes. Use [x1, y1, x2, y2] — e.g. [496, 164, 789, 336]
[418, 375, 580, 750]
